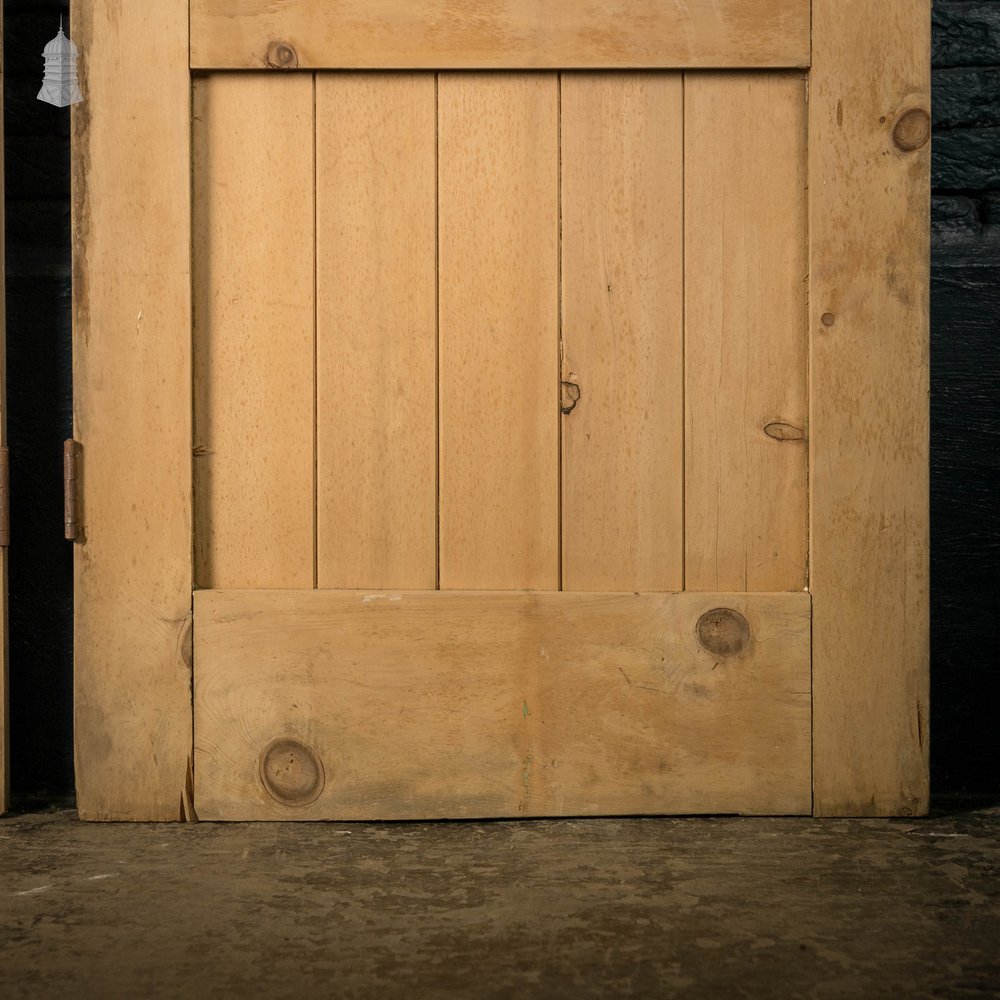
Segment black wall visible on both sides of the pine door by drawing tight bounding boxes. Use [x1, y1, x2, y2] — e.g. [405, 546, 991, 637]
[4, 0, 1000, 807]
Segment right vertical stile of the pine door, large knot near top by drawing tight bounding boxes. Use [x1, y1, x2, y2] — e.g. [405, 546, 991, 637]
[809, 0, 930, 815]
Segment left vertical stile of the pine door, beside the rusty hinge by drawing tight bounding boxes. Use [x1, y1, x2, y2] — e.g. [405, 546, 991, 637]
[73, 0, 191, 820]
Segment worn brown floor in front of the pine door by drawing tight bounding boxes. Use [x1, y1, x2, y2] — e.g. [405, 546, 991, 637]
[0, 807, 1000, 1000]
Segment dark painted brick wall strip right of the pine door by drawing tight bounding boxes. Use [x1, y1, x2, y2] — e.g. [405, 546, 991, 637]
[931, 0, 1000, 792]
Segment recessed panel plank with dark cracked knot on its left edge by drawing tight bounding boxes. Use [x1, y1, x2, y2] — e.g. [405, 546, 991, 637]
[561, 73, 684, 591]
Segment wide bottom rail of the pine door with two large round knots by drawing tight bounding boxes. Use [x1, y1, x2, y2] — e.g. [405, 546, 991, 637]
[195, 591, 811, 819]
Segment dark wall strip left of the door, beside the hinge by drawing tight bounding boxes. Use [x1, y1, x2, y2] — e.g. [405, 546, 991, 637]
[4, 0, 73, 803]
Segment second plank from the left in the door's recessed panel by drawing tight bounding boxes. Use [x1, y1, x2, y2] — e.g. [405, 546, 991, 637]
[316, 73, 437, 590]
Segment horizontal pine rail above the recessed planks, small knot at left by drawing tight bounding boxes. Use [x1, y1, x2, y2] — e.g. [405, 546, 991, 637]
[191, 0, 809, 69]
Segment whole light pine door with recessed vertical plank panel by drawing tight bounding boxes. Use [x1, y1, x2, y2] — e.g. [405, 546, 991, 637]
[73, 0, 929, 819]
